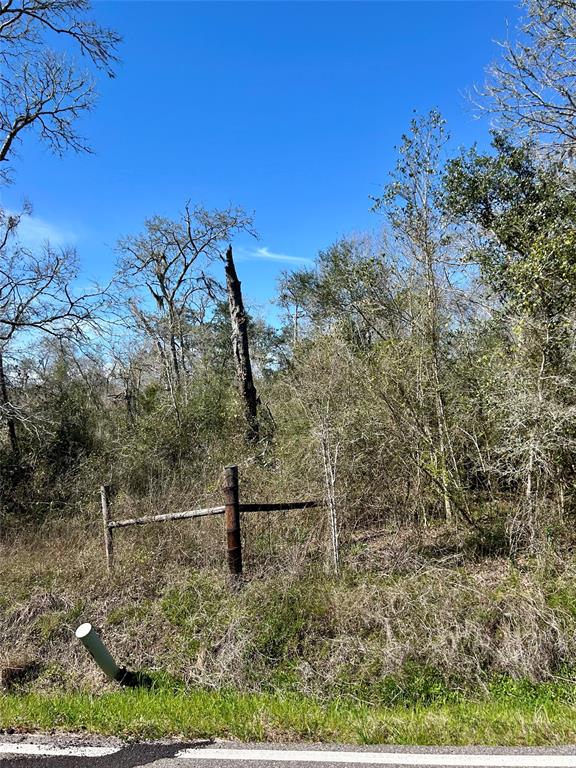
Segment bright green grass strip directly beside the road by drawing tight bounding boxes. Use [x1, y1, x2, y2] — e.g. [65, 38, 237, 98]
[0, 691, 576, 746]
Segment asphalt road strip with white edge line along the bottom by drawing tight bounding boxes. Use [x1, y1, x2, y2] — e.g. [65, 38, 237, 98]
[0, 736, 576, 768]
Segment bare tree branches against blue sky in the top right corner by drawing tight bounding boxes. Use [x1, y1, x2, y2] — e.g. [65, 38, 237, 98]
[480, 0, 576, 154]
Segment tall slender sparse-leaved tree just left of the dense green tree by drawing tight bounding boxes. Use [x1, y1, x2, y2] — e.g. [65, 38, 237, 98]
[375, 110, 460, 522]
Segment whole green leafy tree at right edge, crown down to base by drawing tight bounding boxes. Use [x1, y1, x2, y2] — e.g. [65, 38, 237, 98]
[444, 134, 576, 546]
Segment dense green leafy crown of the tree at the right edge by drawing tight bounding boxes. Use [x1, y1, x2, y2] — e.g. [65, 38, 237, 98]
[443, 133, 576, 322]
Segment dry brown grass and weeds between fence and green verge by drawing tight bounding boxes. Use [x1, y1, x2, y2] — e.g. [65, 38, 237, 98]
[0, 510, 576, 697]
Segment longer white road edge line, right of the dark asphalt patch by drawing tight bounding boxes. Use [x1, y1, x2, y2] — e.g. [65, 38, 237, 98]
[174, 749, 576, 768]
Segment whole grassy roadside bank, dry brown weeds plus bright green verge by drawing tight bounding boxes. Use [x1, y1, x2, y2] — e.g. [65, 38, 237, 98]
[0, 530, 576, 746]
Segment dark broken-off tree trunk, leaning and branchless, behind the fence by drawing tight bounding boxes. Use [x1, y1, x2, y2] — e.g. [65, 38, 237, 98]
[226, 245, 259, 443]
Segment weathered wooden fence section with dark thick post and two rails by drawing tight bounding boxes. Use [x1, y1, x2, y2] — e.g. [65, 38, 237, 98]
[100, 466, 321, 577]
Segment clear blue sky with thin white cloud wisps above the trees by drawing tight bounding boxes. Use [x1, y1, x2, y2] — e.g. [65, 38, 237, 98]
[2, 0, 518, 311]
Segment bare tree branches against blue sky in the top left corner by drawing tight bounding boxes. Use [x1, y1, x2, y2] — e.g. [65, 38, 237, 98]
[0, 0, 120, 180]
